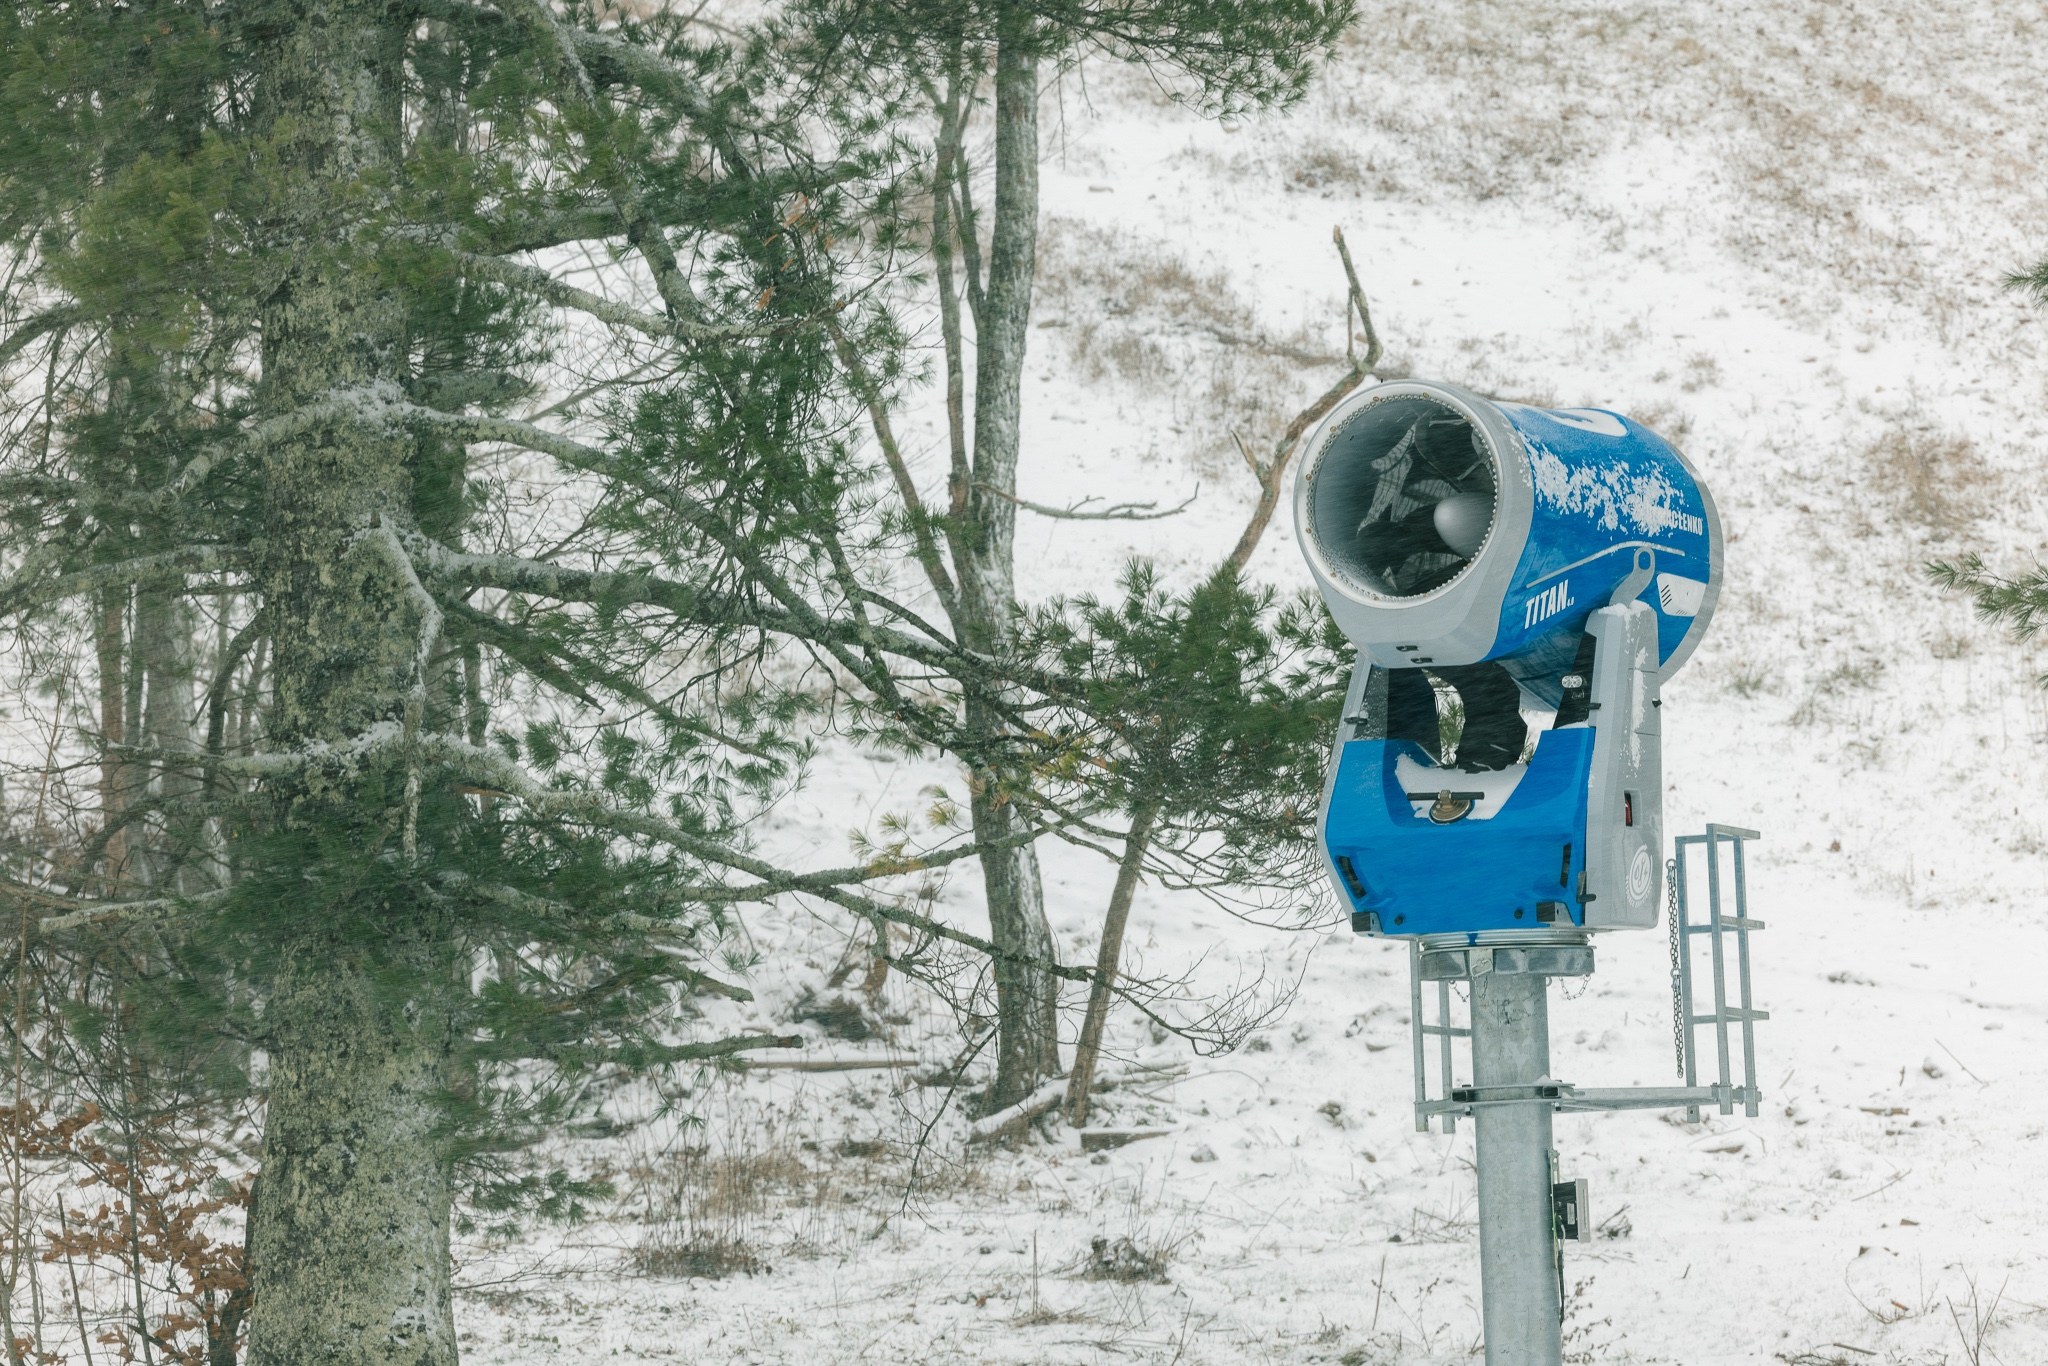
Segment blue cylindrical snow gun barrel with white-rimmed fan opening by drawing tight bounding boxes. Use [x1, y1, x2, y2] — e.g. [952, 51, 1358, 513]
[1294, 379, 1720, 707]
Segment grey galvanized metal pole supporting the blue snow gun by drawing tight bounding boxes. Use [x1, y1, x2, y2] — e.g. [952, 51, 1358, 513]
[1473, 973, 1565, 1366]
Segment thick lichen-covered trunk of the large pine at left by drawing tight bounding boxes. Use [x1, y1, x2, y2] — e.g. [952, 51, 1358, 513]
[248, 0, 457, 1366]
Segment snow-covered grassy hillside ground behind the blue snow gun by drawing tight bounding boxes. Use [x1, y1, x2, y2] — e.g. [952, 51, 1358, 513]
[461, 0, 2048, 1366]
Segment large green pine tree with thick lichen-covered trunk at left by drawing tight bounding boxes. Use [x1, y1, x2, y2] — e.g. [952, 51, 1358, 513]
[0, 0, 954, 1366]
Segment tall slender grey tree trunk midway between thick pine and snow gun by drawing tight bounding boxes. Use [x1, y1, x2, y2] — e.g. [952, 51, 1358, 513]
[961, 24, 1059, 1108]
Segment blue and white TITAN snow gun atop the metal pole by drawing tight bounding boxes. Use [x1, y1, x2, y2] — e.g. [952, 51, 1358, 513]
[1294, 381, 1722, 944]
